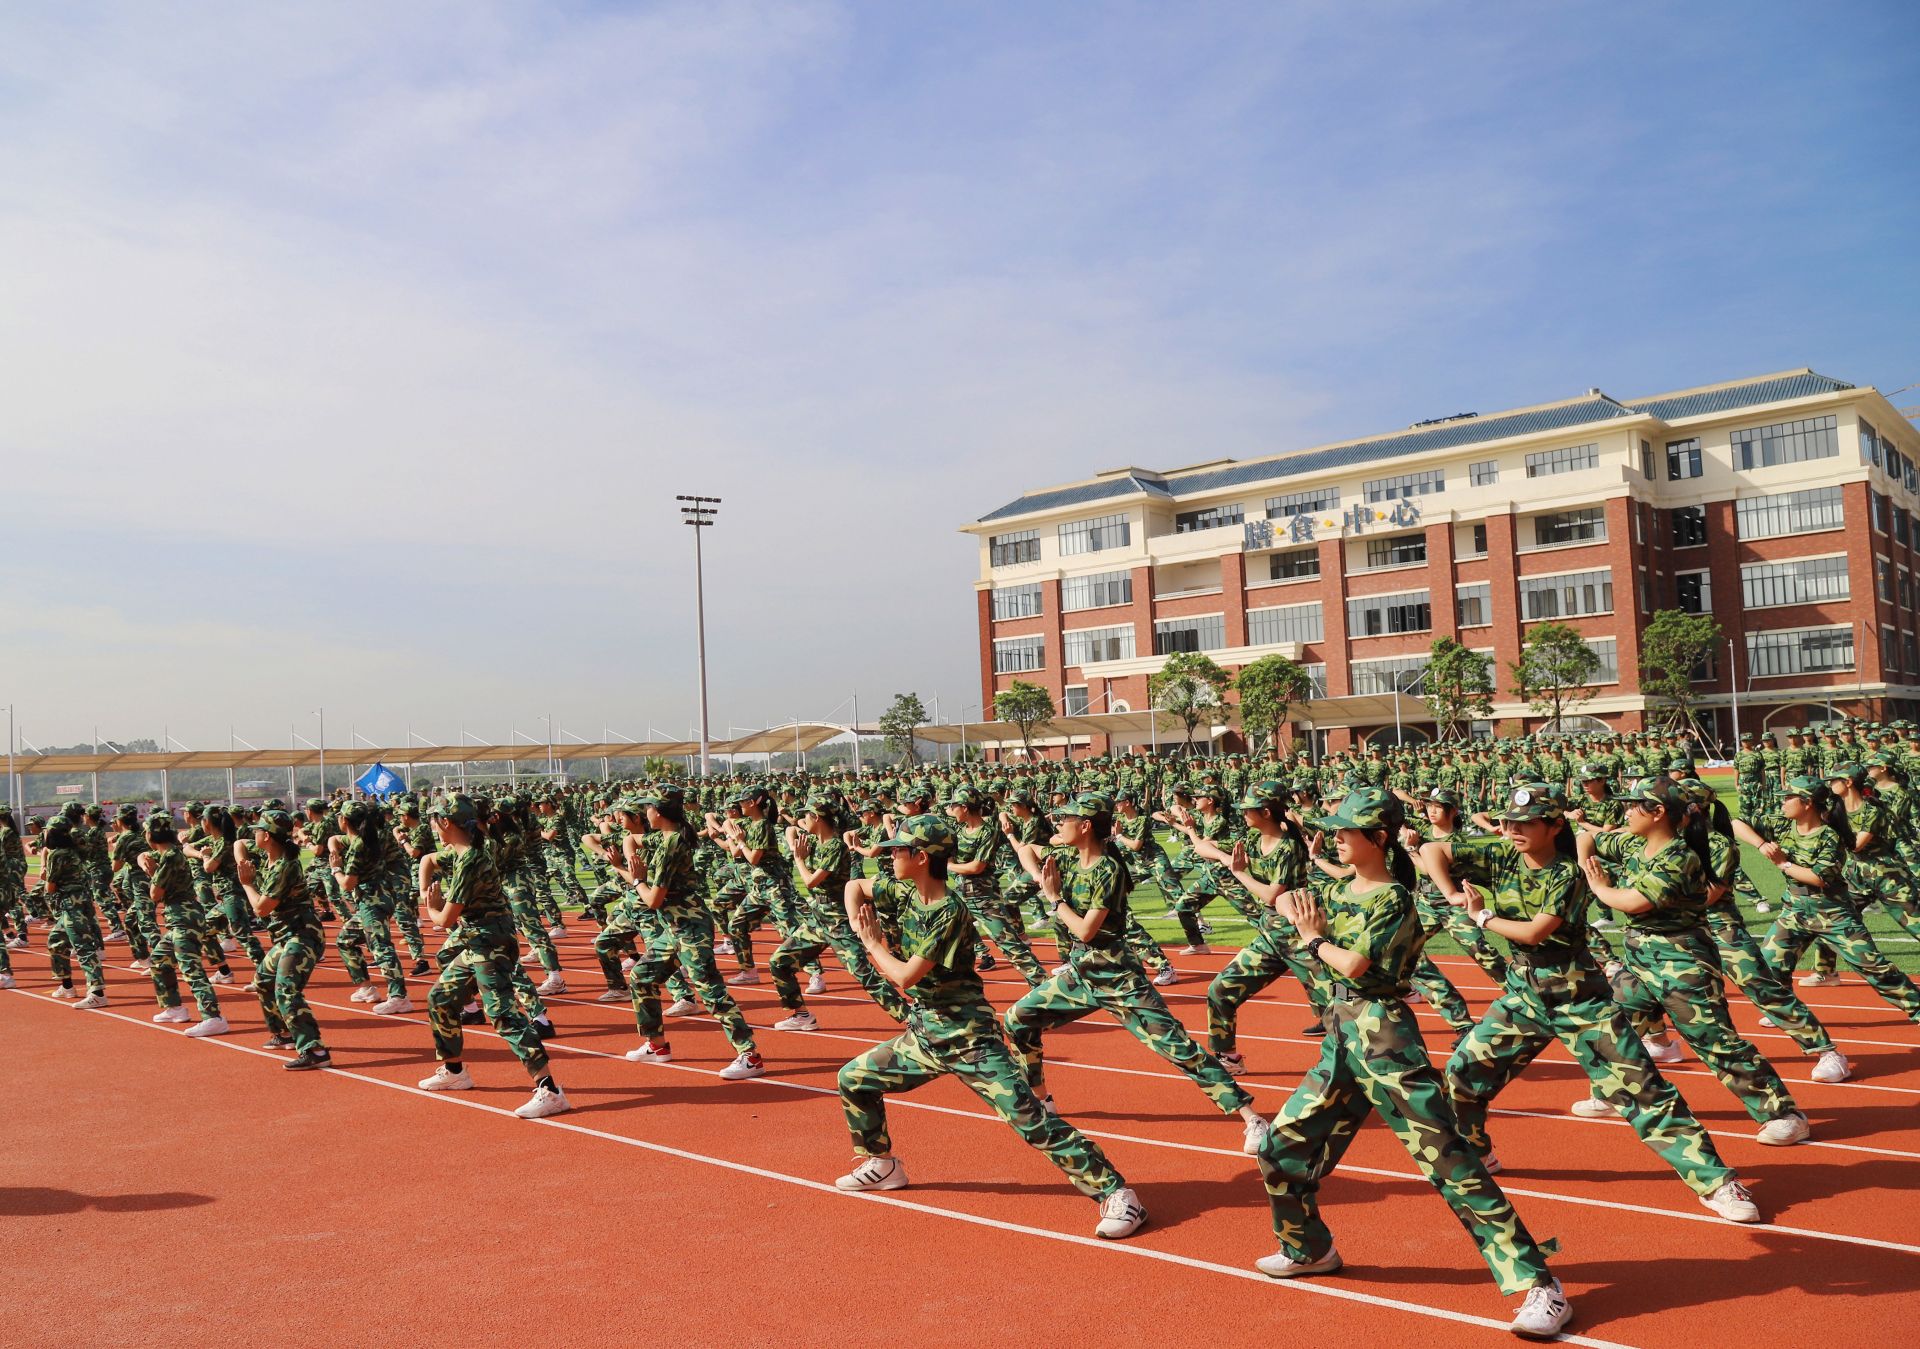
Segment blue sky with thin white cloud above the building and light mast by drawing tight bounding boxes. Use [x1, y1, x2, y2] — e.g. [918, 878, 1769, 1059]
[0, 0, 1920, 746]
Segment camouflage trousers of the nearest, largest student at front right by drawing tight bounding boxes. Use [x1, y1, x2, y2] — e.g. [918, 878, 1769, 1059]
[1258, 1000, 1553, 1293]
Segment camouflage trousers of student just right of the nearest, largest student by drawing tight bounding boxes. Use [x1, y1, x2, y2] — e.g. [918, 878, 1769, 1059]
[1446, 967, 1734, 1195]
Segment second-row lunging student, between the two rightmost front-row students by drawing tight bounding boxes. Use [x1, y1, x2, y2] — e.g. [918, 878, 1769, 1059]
[1006, 796, 1267, 1153]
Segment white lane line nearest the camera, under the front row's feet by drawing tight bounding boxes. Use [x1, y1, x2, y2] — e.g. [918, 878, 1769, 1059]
[13, 988, 1628, 1349]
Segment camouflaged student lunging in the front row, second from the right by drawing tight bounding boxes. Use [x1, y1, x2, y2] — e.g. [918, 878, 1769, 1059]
[833, 816, 1146, 1238]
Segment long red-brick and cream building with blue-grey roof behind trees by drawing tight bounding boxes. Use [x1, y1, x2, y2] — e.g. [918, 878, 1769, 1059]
[964, 370, 1920, 754]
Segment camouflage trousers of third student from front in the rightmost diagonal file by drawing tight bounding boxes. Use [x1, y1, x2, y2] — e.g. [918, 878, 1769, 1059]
[1613, 927, 1799, 1123]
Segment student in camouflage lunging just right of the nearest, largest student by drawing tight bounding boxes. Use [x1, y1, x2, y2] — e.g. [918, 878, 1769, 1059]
[1421, 783, 1761, 1222]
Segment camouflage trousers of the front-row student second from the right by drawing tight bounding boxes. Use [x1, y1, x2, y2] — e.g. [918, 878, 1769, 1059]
[839, 1007, 1127, 1199]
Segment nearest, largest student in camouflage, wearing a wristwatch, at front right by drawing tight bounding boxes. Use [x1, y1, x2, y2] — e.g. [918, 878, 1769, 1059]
[1258, 787, 1572, 1336]
